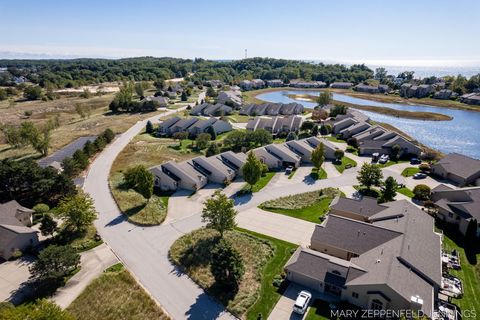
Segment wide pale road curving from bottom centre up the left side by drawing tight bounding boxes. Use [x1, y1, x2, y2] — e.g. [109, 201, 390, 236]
[84, 95, 237, 319]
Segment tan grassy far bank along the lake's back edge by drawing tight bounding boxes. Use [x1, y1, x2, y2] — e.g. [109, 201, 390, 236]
[242, 87, 480, 112]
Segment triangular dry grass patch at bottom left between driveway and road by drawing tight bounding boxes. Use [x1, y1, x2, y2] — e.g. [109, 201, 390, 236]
[67, 266, 169, 320]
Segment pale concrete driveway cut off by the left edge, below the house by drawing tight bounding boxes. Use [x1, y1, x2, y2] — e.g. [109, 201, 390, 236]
[0, 255, 35, 303]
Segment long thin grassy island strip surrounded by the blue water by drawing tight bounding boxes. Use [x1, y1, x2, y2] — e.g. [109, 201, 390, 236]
[287, 94, 453, 121]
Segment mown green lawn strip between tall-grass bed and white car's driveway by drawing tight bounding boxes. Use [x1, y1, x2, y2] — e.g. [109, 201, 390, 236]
[238, 229, 297, 320]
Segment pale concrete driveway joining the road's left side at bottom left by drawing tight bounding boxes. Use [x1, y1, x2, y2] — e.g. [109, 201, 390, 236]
[51, 244, 118, 309]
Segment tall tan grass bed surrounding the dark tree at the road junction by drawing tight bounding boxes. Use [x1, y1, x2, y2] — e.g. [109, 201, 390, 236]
[169, 229, 275, 317]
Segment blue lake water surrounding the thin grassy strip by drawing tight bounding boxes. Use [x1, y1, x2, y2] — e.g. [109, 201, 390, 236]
[257, 90, 480, 159]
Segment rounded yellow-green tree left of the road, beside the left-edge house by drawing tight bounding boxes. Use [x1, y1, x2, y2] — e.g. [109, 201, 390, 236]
[57, 191, 97, 232]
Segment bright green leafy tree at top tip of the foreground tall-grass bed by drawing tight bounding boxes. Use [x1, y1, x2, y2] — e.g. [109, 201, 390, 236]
[202, 190, 237, 238]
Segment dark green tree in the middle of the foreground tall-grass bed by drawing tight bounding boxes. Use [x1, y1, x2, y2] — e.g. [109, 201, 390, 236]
[210, 239, 245, 291]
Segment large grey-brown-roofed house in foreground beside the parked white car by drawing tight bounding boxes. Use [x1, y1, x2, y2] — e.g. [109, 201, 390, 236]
[285, 200, 442, 318]
